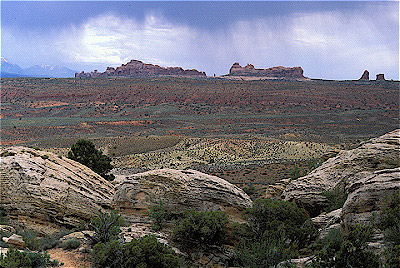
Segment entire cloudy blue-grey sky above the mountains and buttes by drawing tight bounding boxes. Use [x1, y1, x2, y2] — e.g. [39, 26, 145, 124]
[1, 0, 399, 80]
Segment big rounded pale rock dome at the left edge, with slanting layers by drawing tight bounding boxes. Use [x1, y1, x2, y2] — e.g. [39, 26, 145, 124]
[0, 147, 114, 232]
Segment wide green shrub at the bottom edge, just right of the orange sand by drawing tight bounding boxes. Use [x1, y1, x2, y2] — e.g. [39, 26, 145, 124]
[92, 236, 180, 268]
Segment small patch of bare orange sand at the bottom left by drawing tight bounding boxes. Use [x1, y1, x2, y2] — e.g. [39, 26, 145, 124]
[48, 248, 92, 268]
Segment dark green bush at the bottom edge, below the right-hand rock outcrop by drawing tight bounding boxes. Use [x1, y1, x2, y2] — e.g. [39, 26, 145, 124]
[312, 226, 379, 268]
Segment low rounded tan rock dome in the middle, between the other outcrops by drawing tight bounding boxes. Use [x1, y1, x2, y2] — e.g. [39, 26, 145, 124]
[113, 169, 251, 221]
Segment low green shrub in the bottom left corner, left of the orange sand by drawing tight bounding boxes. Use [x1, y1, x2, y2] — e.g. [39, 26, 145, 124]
[0, 248, 58, 268]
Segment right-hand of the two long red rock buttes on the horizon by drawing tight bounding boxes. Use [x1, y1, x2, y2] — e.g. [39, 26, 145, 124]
[229, 62, 305, 79]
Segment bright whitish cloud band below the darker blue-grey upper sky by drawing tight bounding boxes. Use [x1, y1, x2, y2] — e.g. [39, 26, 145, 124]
[3, 3, 399, 79]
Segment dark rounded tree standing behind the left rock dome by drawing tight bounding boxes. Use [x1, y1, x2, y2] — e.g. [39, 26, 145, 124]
[68, 140, 114, 180]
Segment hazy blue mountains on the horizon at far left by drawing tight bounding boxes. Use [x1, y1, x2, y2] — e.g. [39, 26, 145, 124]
[1, 57, 76, 77]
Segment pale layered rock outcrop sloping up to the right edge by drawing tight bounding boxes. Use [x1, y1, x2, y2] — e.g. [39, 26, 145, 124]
[282, 129, 400, 225]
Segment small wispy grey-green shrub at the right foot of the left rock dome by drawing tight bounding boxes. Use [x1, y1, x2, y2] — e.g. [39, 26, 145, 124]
[86, 211, 124, 244]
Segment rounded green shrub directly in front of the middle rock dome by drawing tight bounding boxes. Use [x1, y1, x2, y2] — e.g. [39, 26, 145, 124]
[172, 210, 229, 249]
